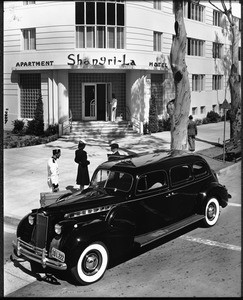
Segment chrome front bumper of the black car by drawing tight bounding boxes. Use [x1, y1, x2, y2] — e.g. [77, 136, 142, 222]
[13, 238, 67, 270]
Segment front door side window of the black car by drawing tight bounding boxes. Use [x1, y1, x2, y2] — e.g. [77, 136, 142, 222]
[137, 171, 168, 193]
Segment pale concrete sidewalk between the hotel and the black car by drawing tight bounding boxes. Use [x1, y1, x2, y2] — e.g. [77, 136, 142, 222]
[3, 122, 240, 223]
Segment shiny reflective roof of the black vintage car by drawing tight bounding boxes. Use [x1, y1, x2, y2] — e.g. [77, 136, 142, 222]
[99, 151, 206, 173]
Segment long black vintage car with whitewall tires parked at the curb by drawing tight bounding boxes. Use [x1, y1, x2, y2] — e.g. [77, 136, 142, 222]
[13, 153, 230, 284]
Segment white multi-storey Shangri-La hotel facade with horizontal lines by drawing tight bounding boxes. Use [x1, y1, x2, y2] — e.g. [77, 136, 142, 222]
[4, 1, 240, 133]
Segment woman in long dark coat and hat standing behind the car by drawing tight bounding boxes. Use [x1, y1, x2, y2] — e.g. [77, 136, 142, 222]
[74, 140, 90, 191]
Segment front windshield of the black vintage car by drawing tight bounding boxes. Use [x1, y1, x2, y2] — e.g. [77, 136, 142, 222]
[91, 169, 133, 192]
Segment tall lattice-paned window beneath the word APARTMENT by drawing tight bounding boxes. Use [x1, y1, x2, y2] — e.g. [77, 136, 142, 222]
[19, 73, 41, 119]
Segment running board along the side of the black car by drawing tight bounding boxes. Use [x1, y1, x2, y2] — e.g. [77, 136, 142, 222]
[134, 215, 204, 247]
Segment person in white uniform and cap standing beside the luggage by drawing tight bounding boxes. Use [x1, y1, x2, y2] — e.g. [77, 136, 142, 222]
[47, 149, 61, 192]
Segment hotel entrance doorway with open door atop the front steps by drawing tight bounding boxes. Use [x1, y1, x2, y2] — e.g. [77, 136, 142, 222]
[82, 83, 111, 121]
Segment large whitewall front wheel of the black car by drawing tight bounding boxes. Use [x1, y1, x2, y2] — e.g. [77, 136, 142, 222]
[71, 242, 109, 285]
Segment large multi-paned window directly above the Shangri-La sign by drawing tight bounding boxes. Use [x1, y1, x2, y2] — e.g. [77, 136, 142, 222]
[75, 1, 125, 49]
